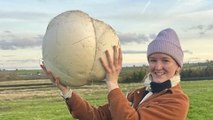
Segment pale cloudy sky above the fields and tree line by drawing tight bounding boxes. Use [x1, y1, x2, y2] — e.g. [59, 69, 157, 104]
[0, 0, 213, 69]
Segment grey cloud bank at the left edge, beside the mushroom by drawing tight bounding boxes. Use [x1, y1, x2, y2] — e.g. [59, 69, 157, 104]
[0, 31, 43, 50]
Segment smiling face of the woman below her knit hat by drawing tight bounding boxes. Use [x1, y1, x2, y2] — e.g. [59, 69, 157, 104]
[148, 53, 180, 83]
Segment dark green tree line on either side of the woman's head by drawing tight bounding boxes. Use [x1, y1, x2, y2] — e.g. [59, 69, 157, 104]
[119, 60, 213, 83]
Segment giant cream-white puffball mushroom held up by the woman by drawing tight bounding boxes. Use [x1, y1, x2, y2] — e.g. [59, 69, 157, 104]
[42, 10, 120, 86]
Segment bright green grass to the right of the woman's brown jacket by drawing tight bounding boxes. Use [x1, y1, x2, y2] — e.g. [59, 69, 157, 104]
[182, 80, 213, 120]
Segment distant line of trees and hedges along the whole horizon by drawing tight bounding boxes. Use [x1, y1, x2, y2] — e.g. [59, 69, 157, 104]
[0, 61, 213, 83]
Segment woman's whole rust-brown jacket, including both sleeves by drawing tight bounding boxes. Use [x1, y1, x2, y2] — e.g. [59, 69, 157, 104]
[66, 85, 189, 120]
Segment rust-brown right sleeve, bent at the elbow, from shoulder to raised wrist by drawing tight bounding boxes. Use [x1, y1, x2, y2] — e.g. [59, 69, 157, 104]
[108, 88, 188, 120]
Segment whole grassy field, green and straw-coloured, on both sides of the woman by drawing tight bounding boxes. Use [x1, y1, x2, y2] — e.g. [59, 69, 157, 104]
[0, 80, 213, 120]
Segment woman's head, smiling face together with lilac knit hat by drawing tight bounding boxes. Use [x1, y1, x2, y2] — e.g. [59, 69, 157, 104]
[147, 29, 183, 83]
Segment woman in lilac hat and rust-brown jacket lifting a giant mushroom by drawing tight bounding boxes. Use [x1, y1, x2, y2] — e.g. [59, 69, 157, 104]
[41, 28, 189, 120]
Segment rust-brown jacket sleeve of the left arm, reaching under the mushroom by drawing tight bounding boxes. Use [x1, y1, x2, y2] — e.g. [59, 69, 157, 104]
[66, 92, 111, 120]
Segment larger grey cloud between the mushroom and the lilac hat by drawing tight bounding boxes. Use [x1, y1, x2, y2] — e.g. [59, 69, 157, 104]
[118, 33, 155, 45]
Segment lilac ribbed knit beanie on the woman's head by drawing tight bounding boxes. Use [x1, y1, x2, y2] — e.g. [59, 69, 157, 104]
[147, 28, 184, 67]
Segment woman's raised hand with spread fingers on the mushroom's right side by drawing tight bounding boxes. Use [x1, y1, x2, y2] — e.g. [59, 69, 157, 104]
[100, 46, 122, 92]
